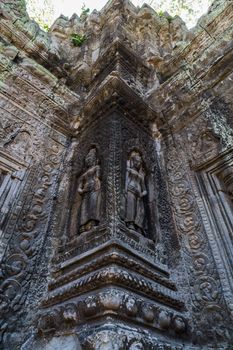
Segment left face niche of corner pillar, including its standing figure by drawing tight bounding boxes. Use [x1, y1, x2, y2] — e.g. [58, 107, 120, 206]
[65, 115, 111, 248]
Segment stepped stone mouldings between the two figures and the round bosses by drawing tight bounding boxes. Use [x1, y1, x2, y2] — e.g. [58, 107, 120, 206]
[40, 238, 184, 310]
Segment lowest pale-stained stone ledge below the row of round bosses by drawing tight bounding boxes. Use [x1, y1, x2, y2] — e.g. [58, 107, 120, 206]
[20, 324, 230, 350]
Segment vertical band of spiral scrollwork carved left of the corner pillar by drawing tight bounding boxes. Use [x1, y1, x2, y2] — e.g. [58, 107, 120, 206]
[1, 139, 65, 340]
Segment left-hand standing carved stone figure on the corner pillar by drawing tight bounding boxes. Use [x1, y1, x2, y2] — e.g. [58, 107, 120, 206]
[78, 147, 101, 232]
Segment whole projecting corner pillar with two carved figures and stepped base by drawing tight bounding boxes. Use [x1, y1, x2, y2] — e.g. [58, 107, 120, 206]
[37, 100, 186, 348]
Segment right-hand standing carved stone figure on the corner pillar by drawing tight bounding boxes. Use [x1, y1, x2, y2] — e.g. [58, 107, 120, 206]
[125, 151, 147, 234]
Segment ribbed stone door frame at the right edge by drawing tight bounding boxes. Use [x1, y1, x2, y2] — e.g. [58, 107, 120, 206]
[193, 149, 233, 317]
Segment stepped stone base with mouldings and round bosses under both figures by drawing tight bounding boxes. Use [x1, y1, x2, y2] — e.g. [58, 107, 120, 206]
[32, 233, 190, 349]
